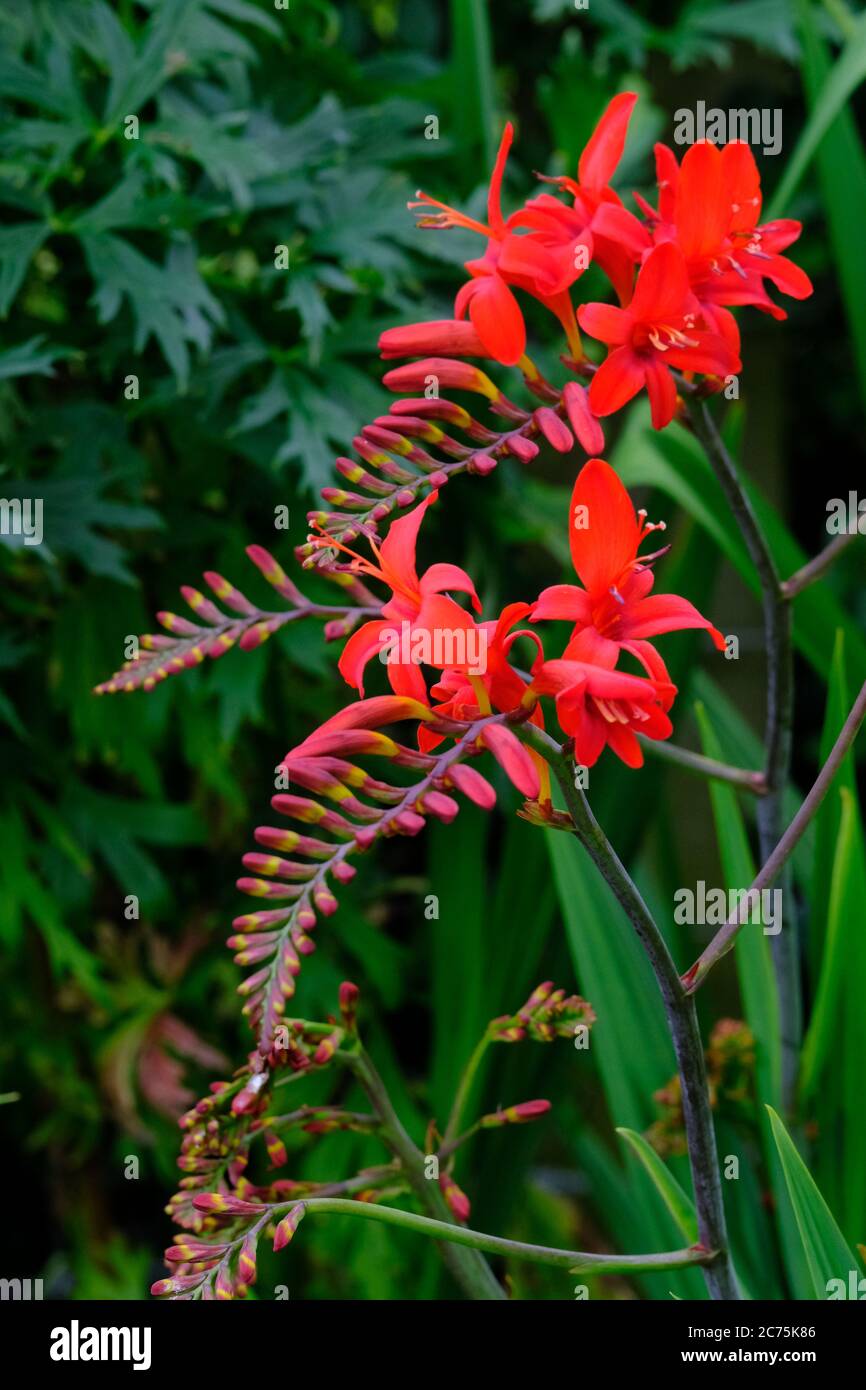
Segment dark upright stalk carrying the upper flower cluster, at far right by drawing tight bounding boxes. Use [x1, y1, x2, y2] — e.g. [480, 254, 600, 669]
[685, 404, 802, 1111]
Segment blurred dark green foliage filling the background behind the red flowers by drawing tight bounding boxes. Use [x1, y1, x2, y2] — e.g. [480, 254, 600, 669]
[0, 0, 866, 1298]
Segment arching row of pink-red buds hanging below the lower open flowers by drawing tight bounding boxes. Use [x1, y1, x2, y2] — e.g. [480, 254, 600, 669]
[228, 695, 538, 1065]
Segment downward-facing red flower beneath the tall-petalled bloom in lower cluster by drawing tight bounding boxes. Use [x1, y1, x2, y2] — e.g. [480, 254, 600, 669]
[531, 637, 677, 767]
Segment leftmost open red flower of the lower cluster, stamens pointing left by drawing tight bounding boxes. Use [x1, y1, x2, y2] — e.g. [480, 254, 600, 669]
[311, 492, 481, 703]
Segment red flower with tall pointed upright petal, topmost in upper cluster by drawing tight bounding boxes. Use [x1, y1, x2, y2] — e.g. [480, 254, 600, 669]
[507, 92, 652, 303]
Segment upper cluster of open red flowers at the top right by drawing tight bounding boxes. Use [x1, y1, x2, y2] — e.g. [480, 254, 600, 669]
[400, 92, 812, 430]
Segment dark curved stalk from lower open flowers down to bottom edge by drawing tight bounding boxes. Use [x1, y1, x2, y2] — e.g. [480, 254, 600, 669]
[516, 724, 740, 1300]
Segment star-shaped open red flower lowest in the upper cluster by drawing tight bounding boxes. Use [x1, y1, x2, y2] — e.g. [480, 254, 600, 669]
[577, 242, 741, 430]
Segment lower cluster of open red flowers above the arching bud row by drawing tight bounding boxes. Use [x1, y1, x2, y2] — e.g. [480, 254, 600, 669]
[314, 459, 724, 778]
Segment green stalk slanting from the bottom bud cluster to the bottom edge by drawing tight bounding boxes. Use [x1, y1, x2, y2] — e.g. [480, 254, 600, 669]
[345, 1047, 506, 1301]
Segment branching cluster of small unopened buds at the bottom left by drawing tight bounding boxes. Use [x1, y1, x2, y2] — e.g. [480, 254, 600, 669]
[152, 981, 595, 1301]
